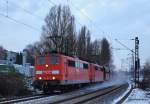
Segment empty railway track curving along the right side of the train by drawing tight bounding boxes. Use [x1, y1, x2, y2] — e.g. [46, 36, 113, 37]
[49, 84, 127, 104]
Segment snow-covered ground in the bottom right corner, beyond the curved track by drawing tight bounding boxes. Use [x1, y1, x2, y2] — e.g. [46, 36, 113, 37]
[123, 88, 150, 104]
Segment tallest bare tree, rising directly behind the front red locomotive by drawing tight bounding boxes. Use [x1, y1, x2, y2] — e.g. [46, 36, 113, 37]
[41, 5, 75, 52]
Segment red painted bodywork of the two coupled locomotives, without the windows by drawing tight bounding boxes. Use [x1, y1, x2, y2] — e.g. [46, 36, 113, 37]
[35, 54, 109, 83]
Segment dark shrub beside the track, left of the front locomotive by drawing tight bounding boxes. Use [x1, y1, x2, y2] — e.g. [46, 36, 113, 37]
[0, 73, 30, 96]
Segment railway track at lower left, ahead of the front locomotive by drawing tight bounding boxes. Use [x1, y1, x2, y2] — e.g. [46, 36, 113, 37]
[0, 94, 48, 104]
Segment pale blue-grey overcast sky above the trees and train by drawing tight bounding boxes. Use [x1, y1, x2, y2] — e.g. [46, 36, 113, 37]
[0, 0, 150, 68]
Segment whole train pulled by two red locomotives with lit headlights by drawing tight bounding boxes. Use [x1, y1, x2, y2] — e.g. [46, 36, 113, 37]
[34, 53, 110, 92]
